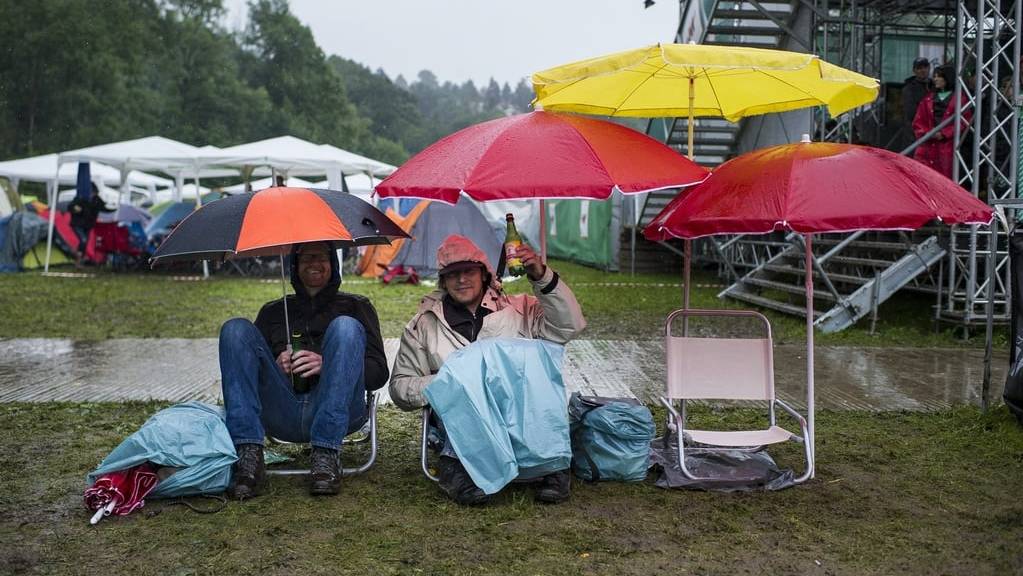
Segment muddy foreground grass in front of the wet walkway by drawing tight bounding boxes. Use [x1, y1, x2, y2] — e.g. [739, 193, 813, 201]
[0, 403, 1023, 575]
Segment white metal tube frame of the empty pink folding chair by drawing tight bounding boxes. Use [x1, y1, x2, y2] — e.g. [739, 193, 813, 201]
[660, 309, 814, 484]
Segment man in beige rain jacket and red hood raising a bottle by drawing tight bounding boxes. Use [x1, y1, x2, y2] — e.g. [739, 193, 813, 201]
[390, 234, 586, 504]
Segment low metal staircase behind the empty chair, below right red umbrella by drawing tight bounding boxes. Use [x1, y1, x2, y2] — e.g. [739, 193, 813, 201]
[718, 232, 945, 333]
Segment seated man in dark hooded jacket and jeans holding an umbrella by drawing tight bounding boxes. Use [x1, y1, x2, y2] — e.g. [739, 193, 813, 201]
[220, 242, 388, 498]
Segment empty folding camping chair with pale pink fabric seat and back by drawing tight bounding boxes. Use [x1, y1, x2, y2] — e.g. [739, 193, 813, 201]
[661, 310, 813, 484]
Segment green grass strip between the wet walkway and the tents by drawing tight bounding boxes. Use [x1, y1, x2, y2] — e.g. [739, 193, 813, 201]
[0, 262, 1007, 347]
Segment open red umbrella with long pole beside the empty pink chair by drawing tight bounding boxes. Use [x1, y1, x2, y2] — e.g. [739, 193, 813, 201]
[643, 136, 992, 480]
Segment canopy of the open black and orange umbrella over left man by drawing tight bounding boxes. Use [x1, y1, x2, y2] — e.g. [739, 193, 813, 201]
[150, 187, 408, 265]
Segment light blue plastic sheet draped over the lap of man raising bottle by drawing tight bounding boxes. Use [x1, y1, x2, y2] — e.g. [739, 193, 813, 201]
[425, 339, 572, 494]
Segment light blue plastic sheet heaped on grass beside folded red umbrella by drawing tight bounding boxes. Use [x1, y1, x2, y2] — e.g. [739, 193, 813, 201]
[86, 402, 237, 498]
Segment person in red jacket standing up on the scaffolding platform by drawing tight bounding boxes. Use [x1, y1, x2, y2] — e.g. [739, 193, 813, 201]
[913, 65, 973, 178]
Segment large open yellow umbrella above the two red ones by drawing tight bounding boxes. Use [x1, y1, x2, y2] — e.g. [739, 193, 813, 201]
[532, 44, 878, 160]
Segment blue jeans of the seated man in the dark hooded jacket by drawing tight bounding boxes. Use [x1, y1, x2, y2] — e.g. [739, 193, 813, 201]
[220, 316, 367, 450]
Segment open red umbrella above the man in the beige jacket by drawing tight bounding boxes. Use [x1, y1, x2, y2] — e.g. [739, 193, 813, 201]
[376, 112, 707, 263]
